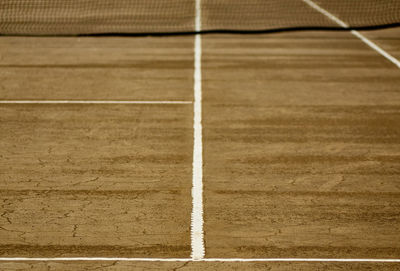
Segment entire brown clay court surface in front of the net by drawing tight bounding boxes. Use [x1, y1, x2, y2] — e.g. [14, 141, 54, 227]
[0, 28, 400, 271]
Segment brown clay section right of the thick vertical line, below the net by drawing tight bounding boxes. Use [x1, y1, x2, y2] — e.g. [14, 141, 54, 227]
[203, 28, 400, 258]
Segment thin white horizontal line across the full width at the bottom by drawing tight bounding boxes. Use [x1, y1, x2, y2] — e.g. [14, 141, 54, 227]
[0, 257, 400, 263]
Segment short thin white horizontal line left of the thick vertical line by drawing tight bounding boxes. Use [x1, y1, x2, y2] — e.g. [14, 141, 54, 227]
[0, 100, 193, 104]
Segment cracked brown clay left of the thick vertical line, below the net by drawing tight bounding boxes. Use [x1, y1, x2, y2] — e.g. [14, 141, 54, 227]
[0, 37, 193, 257]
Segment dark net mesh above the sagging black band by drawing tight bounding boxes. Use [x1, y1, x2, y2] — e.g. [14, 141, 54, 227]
[0, 0, 400, 35]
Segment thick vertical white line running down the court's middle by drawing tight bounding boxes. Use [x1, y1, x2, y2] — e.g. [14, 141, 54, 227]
[191, 0, 205, 260]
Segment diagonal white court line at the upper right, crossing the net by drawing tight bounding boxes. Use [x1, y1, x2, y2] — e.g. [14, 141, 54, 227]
[303, 0, 400, 69]
